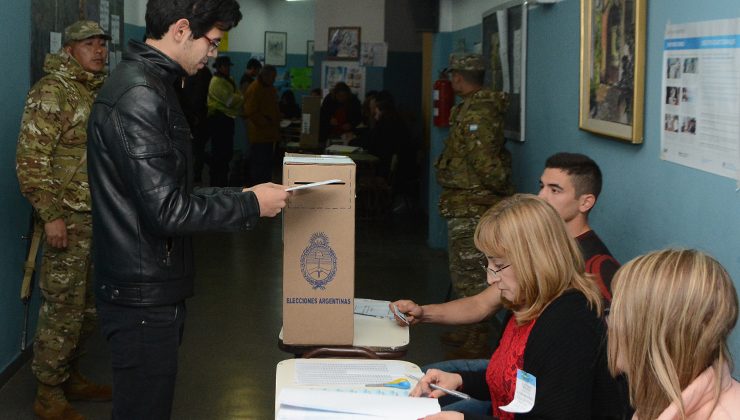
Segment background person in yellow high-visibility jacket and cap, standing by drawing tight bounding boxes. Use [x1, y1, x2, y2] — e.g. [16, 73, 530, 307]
[208, 55, 244, 187]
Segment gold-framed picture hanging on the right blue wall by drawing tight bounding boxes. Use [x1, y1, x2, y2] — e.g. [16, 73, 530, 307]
[578, 0, 647, 144]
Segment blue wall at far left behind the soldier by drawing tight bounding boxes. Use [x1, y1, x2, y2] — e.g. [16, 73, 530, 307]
[0, 2, 38, 372]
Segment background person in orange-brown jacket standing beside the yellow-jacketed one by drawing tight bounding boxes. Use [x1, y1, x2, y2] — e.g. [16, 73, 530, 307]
[244, 65, 280, 183]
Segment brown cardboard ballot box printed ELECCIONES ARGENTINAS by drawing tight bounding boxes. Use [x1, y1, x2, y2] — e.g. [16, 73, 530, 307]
[283, 154, 355, 345]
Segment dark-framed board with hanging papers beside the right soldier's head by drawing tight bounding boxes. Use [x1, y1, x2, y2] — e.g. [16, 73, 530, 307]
[482, 0, 527, 141]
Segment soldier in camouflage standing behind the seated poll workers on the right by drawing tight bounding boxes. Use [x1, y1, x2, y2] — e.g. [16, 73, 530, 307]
[435, 54, 513, 358]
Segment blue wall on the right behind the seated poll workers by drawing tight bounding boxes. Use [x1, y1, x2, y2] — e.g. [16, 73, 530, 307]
[430, 0, 740, 376]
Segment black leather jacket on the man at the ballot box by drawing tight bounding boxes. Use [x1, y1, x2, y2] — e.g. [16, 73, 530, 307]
[88, 41, 259, 306]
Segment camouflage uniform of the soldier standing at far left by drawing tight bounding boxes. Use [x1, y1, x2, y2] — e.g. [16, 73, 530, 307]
[16, 39, 104, 386]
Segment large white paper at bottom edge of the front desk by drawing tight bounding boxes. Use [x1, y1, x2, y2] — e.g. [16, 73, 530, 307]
[277, 388, 440, 420]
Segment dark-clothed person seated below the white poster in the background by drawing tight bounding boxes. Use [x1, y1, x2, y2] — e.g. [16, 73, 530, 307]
[319, 82, 362, 143]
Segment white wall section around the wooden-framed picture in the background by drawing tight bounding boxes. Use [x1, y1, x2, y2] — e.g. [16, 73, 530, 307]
[314, 0, 385, 51]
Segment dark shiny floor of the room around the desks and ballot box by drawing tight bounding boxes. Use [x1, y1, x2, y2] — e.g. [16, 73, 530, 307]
[0, 215, 449, 420]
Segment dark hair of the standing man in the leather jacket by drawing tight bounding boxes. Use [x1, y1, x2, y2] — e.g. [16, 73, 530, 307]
[145, 0, 242, 39]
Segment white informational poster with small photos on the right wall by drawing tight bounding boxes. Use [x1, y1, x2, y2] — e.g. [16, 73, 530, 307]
[660, 19, 740, 179]
